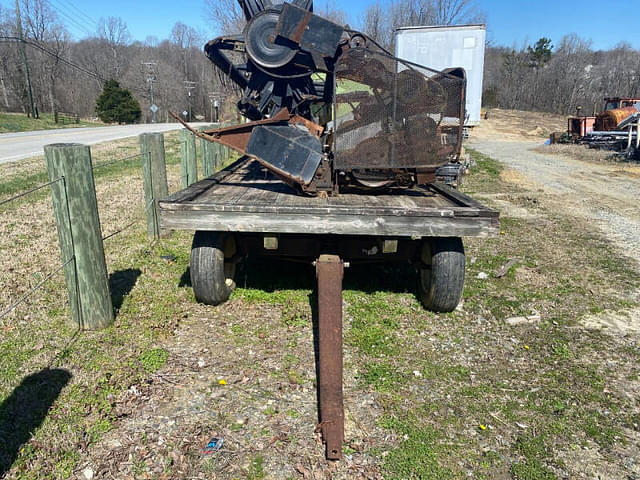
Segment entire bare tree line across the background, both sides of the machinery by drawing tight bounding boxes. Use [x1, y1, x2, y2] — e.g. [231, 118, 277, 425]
[0, 0, 640, 121]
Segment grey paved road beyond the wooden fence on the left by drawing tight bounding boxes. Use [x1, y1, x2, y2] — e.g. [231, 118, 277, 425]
[0, 123, 206, 163]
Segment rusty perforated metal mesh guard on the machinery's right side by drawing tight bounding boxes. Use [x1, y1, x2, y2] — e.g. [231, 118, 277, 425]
[334, 48, 465, 170]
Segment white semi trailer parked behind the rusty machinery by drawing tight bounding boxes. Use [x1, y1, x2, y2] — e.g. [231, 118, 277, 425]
[395, 25, 487, 127]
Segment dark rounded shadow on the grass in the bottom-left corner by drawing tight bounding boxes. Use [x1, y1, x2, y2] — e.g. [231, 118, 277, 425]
[0, 368, 72, 478]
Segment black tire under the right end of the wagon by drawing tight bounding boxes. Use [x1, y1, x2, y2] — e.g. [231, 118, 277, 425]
[418, 237, 465, 313]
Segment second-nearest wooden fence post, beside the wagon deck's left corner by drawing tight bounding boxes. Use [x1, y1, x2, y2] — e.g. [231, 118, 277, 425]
[139, 133, 169, 239]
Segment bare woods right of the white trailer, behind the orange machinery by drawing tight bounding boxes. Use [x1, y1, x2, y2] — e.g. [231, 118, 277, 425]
[483, 34, 640, 115]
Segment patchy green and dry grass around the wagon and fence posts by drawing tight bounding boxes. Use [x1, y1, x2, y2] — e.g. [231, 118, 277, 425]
[0, 135, 640, 480]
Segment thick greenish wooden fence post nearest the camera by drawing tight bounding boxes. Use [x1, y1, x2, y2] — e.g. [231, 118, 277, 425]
[44, 144, 114, 330]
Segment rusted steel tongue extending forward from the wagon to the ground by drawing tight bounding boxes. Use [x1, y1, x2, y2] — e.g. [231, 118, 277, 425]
[316, 255, 344, 460]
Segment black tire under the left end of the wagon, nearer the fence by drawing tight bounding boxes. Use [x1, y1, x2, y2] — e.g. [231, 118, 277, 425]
[191, 231, 236, 305]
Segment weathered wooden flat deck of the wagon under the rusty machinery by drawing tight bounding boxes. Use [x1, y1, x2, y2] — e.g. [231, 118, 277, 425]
[159, 158, 499, 237]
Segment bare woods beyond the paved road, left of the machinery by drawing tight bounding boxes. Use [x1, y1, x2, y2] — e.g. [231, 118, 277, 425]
[0, 0, 224, 121]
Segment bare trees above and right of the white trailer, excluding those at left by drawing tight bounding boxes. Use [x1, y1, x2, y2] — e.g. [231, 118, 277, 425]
[363, 0, 640, 115]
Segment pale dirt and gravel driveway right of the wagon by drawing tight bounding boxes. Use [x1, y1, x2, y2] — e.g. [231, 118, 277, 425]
[469, 111, 640, 332]
